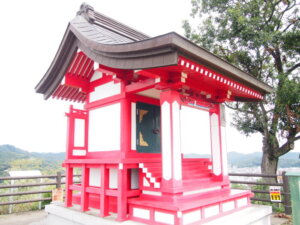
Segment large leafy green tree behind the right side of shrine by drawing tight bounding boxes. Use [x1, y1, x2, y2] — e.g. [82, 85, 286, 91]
[183, 0, 300, 174]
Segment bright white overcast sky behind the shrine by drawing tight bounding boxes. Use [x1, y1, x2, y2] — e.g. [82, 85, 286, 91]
[0, 0, 300, 153]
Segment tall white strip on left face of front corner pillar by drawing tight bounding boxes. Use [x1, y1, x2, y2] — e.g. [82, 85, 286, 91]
[161, 102, 172, 180]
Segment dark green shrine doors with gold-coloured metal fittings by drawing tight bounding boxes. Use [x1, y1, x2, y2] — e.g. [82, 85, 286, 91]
[136, 102, 161, 153]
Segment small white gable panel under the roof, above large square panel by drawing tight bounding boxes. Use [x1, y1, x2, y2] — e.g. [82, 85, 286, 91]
[90, 81, 121, 102]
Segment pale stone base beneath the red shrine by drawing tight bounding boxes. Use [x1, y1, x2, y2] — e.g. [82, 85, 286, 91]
[45, 203, 272, 225]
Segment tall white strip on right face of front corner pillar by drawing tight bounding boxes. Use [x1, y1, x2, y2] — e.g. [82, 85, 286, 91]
[172, 101, 182, 180]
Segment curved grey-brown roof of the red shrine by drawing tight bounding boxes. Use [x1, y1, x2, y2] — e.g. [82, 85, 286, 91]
[36, 4, 272, 99]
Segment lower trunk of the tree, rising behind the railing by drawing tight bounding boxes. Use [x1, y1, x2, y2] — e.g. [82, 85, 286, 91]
[261, 137, 279, 182]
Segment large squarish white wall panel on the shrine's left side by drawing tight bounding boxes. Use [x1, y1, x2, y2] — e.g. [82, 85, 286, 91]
[89, 103, 121, 152]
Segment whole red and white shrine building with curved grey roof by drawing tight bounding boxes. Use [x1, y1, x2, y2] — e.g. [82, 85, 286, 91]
[36, 4, 272, 224]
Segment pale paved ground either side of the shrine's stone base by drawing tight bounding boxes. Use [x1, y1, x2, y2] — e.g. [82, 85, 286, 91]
[0, 211, 291, 225]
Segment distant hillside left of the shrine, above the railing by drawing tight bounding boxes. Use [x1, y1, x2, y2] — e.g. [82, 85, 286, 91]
[0, 145, 65, 176]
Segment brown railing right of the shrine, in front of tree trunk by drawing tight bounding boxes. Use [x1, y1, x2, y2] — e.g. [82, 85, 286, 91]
[229, 172, 292, 215]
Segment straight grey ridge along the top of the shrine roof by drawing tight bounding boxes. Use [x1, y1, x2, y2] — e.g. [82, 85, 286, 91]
[77, 3, 150, 41]
